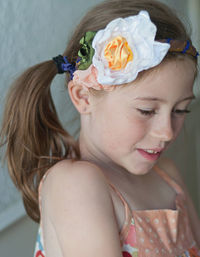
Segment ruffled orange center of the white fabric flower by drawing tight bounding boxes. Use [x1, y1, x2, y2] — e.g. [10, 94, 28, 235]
[104, 36, 133, 70]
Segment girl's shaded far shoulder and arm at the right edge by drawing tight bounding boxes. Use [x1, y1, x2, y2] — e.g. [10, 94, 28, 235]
[158, 158, 200, 247]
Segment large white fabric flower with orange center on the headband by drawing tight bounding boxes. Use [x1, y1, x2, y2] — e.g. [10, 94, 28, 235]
[92, 11, 170, 85]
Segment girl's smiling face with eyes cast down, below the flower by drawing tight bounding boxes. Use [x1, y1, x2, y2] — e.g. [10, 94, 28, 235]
[82, 60, 195, 175]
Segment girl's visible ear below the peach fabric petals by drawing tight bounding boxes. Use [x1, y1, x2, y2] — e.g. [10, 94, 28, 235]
[68, 80, 91, 114]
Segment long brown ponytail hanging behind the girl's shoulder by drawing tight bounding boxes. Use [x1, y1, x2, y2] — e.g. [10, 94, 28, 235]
[0, 61, 80, 222]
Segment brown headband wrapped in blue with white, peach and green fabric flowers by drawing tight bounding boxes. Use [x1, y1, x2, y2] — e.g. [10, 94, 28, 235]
[53, 11, 199, 90]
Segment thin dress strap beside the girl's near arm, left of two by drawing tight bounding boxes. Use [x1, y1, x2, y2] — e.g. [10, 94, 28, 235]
[104, 175, 132, 246]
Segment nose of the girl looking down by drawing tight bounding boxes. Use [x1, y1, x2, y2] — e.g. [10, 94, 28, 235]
[150, 115, 174, 142]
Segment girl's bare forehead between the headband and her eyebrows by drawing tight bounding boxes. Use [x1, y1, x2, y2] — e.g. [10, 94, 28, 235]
[115, 59, 196, 99]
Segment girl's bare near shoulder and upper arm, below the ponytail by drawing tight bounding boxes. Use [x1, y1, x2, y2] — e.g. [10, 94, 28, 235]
[42, 161, 122, 257]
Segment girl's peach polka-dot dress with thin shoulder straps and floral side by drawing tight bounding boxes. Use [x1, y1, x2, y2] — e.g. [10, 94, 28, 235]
[34, 166, 200, 257]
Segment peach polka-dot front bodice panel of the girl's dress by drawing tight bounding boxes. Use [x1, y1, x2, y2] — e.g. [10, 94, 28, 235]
[123, 205, 200, 257]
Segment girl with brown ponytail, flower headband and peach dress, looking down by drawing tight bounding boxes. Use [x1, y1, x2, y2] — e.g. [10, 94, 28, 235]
[1, 0, 200, 257]
